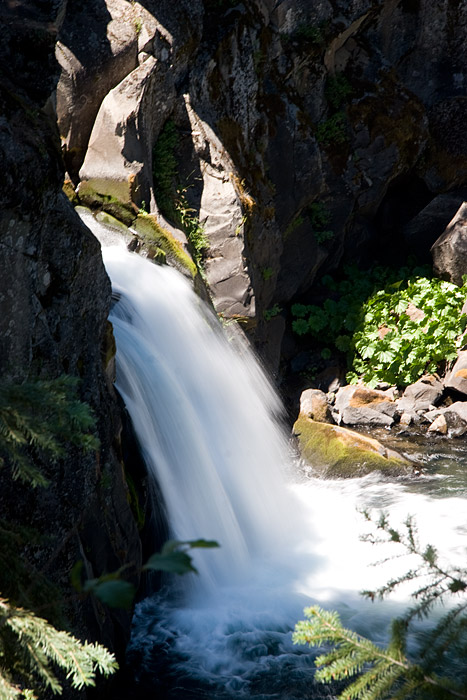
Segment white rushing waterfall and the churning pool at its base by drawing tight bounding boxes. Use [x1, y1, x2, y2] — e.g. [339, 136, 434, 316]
[104, 247, 467, 700]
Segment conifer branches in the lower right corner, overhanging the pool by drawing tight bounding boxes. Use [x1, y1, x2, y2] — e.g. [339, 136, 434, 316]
[293, 513, 467, 700]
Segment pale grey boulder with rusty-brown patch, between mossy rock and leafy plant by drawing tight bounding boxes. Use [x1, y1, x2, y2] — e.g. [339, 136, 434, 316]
[334, 385, 397, 426]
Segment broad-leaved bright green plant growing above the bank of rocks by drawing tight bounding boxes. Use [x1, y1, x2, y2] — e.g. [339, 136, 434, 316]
[291, 267, 467, 386]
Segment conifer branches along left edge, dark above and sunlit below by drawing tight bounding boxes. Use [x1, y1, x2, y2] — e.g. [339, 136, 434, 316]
[0, 376, 113, 700]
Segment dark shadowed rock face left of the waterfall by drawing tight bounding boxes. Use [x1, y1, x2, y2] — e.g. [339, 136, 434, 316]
[0, 2, 141, 668]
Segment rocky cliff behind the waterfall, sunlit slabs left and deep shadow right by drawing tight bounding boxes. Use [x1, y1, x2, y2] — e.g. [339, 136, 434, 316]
[57, 0, 467, 370]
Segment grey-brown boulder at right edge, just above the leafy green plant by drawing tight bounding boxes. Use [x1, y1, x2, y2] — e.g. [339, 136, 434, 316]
[431, 202, 467, 285]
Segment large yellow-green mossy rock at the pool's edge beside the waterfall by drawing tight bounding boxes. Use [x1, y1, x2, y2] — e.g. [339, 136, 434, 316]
[293, 415, 412, 478]
